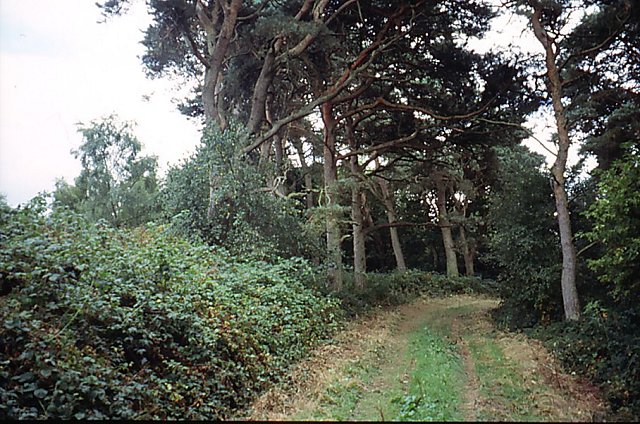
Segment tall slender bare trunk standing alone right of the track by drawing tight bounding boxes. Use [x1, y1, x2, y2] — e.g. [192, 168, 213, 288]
[531, 2, 580, 320]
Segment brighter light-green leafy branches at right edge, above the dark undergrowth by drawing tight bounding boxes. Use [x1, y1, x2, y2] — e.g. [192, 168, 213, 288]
[585, 144, 640, 310]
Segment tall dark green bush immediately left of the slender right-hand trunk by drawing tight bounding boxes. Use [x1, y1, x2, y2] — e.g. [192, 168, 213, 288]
[483, 146, 562, 327]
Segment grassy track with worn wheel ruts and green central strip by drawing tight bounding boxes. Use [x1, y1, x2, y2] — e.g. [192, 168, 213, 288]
[243, 296, 602, 421]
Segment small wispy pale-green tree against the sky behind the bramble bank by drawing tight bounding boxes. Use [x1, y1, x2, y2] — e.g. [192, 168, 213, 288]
[54, 115, 158, 227]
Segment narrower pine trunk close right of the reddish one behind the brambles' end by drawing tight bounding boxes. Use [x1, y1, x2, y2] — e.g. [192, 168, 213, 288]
[350, 156, 367, 289]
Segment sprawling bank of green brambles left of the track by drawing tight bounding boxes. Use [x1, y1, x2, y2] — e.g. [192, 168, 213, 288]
[0, 198, 340, 419]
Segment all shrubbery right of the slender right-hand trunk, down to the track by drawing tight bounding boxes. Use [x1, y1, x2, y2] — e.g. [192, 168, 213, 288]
[538, 143, 640, 421]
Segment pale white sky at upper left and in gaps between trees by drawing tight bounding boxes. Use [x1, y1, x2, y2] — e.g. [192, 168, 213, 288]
[0, 0, 575, 206]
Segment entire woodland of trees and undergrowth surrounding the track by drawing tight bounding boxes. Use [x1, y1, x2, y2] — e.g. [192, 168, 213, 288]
[0, 0, 640, 420]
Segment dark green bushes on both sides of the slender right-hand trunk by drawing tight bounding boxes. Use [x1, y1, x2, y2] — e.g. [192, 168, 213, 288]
[486, 145, 640, 421]
